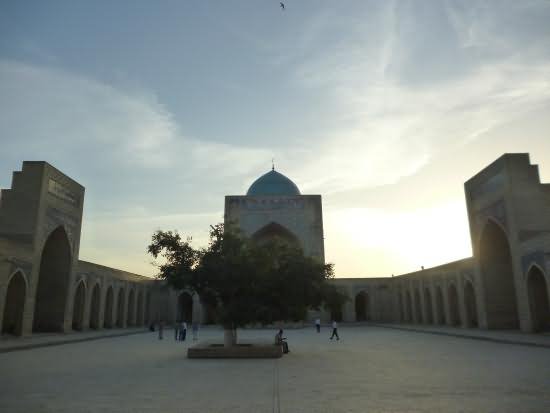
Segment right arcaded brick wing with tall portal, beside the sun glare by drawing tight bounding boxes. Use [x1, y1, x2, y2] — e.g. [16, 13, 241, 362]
[334, 153, 550, 332]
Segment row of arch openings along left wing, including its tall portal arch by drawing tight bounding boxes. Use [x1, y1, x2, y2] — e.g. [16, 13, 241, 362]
[0, 226, 155, 336]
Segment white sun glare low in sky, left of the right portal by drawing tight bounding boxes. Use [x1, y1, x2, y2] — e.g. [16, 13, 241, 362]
[327, 201, 471, 276]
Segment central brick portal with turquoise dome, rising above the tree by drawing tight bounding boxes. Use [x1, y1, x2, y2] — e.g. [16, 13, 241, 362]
[224, 168, 325, 262]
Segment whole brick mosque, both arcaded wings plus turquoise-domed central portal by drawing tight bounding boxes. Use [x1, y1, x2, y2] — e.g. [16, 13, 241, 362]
[0, 154, 550, 336]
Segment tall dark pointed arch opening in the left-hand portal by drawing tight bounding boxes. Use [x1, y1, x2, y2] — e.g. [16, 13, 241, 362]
[33, 227, 71, 332]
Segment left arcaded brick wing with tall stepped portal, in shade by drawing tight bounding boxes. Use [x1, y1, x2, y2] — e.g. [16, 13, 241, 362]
[0, 162, 200, 335]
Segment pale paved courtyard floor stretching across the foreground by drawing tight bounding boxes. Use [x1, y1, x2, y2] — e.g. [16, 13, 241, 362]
[0, 326, 550, 413]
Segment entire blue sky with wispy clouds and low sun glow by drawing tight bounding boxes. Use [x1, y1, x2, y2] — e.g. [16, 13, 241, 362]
[0, 0, 550, 277]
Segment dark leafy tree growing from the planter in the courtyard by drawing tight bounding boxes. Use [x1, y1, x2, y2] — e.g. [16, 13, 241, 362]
[148, 224, 335, 345]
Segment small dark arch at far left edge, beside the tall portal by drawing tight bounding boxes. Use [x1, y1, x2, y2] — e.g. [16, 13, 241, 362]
[2, 271, 27, 336]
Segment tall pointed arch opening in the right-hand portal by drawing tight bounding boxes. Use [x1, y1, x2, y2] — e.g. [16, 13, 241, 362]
[478, 221, 519, 328]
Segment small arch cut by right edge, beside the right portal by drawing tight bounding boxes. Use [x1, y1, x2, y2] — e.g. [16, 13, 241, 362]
[527, 266, 550, 332]
